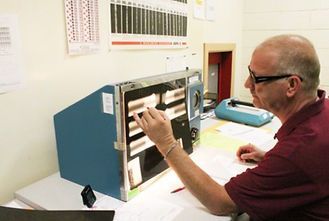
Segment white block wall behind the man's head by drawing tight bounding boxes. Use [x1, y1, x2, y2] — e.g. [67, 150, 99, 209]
[236, 0, 329, 99]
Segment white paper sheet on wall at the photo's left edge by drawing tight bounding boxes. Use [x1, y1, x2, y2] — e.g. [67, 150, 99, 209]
[0, 15, 22, 93]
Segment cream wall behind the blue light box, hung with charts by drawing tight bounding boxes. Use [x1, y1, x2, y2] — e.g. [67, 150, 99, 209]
[0, 0, 242, 204]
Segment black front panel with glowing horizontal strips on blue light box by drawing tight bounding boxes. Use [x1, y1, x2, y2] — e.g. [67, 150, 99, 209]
[124, 78, 192, 189]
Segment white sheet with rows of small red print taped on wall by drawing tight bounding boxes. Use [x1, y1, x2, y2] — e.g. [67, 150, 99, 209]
[64, 0, 100, 55]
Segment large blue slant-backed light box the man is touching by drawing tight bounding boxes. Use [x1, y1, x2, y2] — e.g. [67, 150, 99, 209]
[54, 70, 199, 201]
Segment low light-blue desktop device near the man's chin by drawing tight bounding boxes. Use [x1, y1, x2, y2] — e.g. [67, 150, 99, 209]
[215, 98, 273, 127]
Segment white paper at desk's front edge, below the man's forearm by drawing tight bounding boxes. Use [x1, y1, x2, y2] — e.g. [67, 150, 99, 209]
[114, 190, 231, 221]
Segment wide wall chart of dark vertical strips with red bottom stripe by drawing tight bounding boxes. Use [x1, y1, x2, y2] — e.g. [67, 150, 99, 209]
[109, 0, 188, 49]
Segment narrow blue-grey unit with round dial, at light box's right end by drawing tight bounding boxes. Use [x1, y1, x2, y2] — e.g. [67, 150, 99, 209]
[187, 72, 203, 143]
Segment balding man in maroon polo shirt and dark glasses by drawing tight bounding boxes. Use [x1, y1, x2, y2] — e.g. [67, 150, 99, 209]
[134, 35, 329, 221]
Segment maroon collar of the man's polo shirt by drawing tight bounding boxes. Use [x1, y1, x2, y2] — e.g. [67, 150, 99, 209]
[274, 90, 326, 140]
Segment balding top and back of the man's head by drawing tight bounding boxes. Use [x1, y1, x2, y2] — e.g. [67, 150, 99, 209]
[254, 35, 320, 94]
